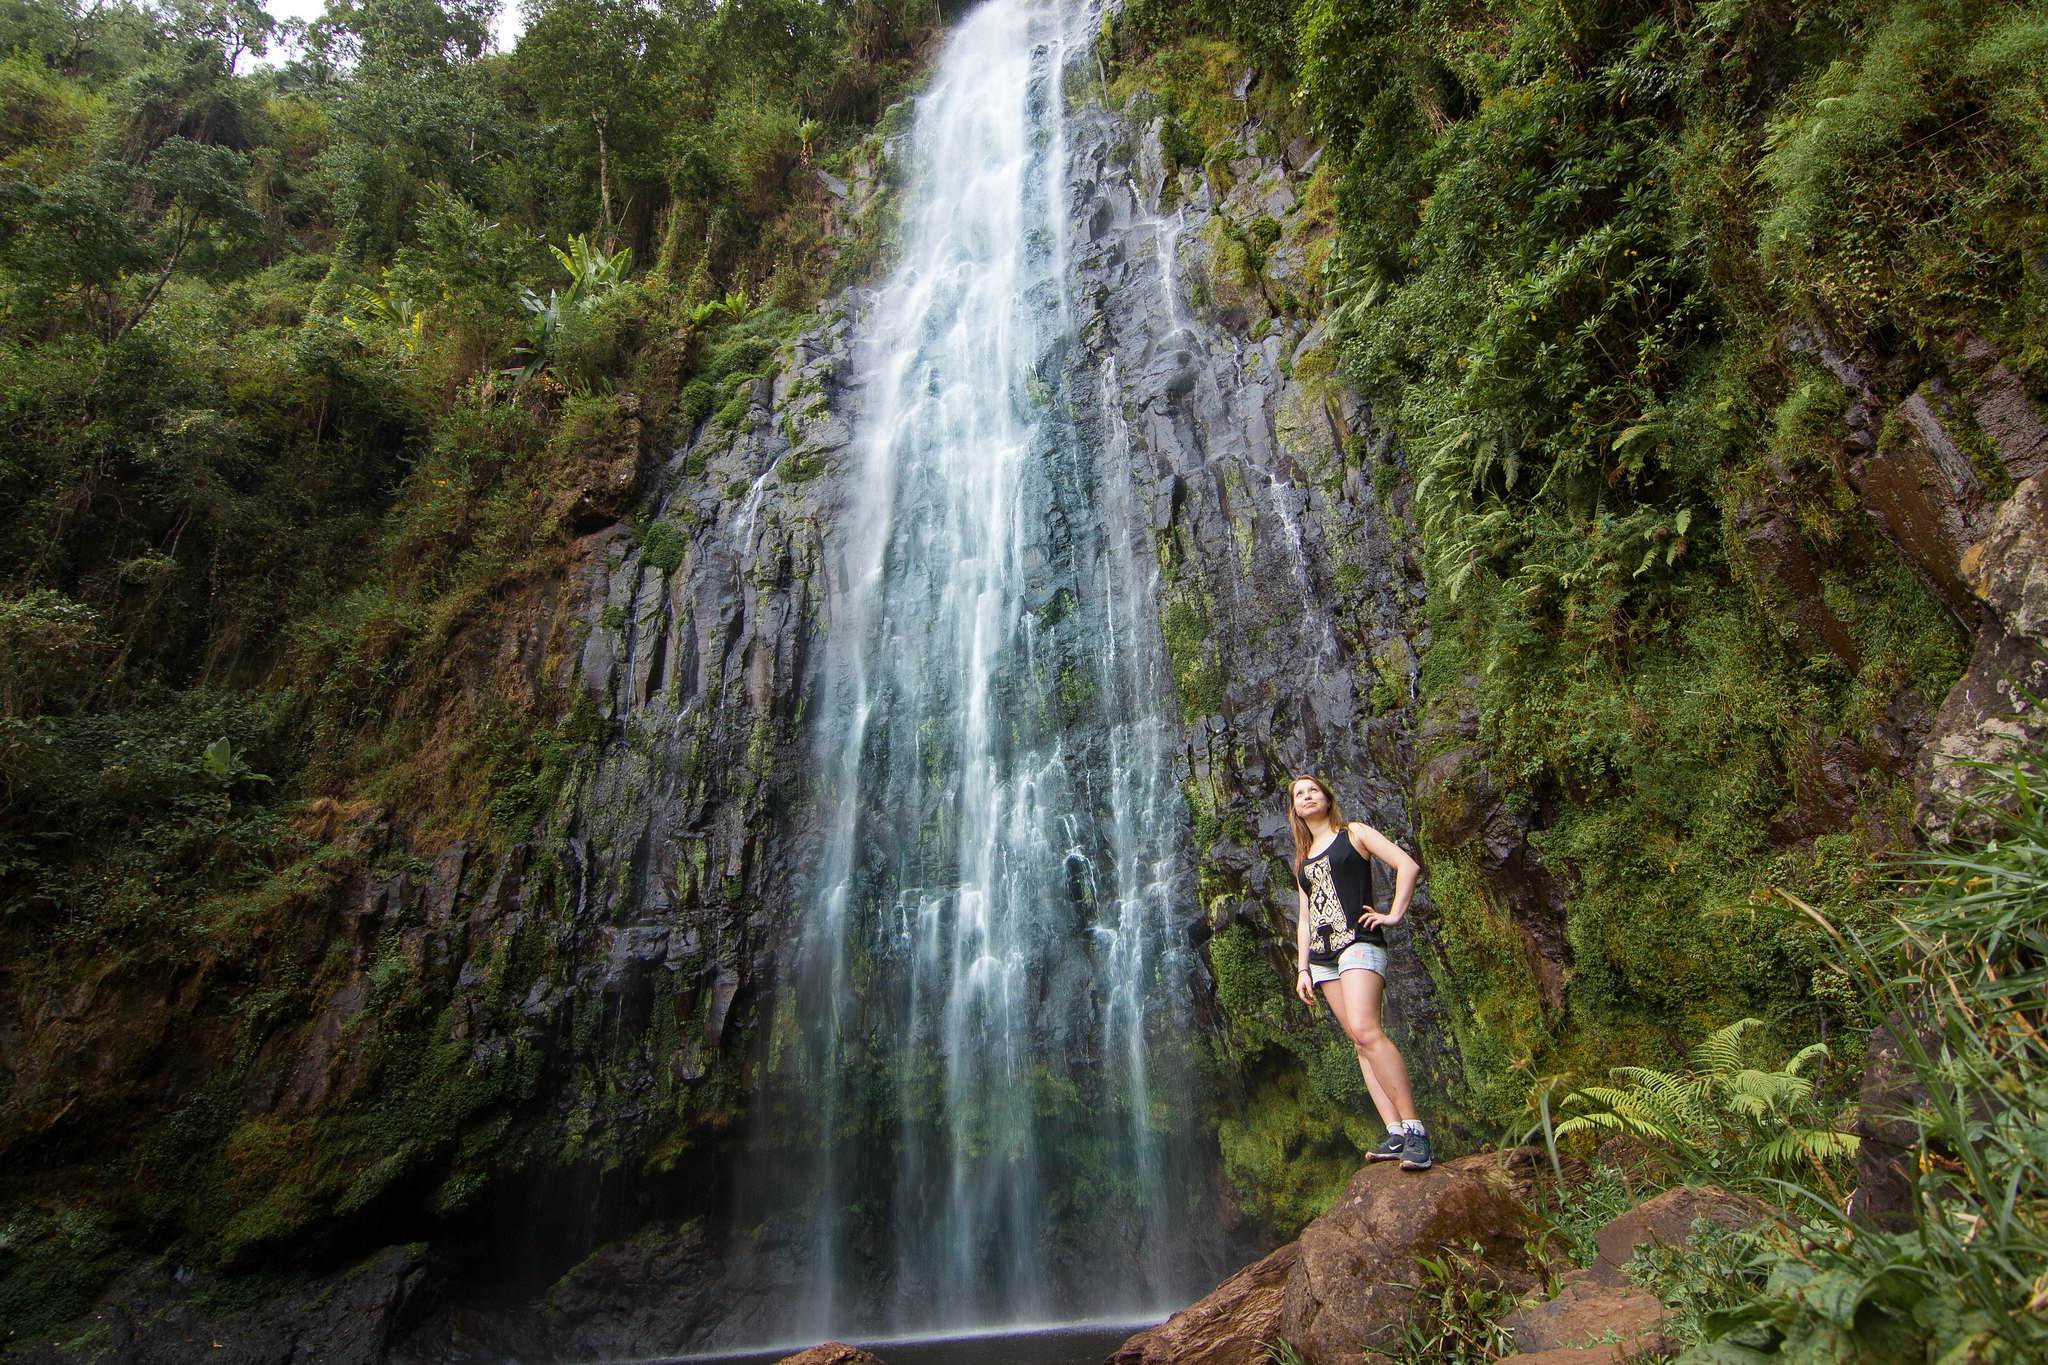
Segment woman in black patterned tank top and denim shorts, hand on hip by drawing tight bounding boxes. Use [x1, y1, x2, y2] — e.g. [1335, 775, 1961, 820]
[1288, 778, 1432, 1171]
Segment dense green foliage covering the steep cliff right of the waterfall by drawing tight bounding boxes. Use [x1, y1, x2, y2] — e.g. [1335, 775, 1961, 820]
[1108, 0, 2048, 1227]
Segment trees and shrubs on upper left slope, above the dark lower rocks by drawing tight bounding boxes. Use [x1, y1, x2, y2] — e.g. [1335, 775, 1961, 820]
[0, 0, 938, 961]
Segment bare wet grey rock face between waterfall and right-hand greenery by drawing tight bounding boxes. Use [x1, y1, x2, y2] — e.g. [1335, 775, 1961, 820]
[1071, 87, 1458, 1093]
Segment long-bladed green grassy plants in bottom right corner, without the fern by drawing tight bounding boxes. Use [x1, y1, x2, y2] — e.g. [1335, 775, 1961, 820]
[1679, 753, 2048, 1365]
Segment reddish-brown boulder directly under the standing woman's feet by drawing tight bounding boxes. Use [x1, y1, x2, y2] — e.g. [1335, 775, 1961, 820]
[1280, 1154, 1536, 1365]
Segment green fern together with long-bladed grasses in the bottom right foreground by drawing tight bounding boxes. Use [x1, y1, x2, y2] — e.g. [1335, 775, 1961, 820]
[1538, 769, 2048, 1365]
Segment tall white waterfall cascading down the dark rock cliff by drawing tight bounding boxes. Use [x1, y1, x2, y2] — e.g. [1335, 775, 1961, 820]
[750, 0, 1202, 1334]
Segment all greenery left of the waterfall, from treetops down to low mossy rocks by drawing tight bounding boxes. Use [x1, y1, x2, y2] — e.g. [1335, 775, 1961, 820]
[0, 0, 942, 1332]
